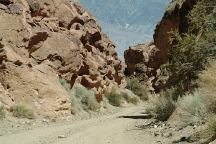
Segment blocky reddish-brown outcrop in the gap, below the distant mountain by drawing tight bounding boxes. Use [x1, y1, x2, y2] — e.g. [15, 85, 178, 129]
[124, 44, 160, 91]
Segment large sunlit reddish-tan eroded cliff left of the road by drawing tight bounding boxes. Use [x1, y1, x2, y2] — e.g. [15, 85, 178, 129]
[0, 0, 125, 116]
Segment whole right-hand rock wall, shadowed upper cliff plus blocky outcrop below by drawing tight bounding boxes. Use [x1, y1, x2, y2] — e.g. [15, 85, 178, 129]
[124, 0, 196, 91]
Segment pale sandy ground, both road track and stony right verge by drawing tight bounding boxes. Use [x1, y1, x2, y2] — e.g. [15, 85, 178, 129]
[0, 105, 211, 144]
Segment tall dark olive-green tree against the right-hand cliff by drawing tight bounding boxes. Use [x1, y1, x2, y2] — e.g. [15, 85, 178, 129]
[163, 0, 216, 90]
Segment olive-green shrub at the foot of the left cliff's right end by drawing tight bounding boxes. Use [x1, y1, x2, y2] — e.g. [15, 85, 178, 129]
[105, 88, 124, 107]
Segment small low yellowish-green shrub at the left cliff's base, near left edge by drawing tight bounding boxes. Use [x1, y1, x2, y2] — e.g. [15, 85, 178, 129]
[10, 105, 35, 119]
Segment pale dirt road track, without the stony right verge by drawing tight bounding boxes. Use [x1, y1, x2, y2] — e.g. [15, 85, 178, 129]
[0, 106, 160, 144]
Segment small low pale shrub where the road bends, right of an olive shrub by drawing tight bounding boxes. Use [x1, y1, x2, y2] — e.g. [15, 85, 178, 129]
[121, 89, 139, 105]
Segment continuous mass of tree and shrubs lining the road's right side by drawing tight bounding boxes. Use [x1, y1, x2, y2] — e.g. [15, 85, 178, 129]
[145, 0, 216, 142]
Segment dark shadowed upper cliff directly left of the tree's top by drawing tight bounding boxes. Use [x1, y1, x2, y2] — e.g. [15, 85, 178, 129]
[154, 0, 197, 64]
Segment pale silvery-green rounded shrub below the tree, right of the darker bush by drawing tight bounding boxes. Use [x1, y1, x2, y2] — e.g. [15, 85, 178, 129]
[177, 91, 208, 123]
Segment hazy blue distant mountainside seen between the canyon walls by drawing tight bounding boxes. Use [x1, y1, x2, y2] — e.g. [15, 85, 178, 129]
[80, 0, 170, 57]
